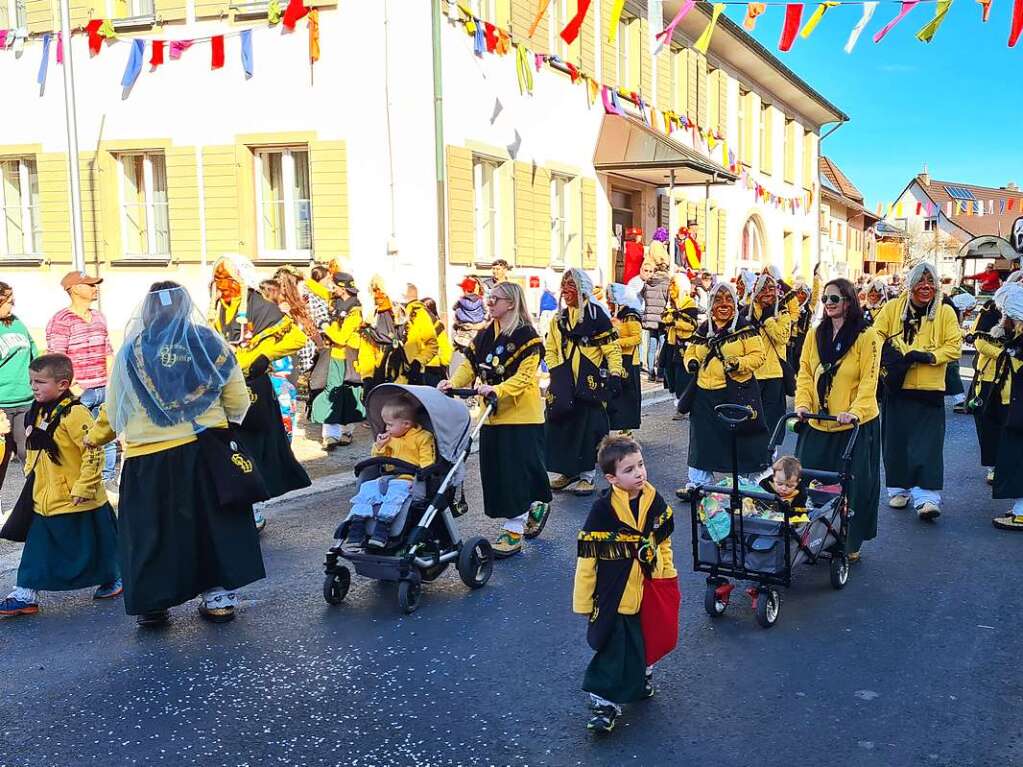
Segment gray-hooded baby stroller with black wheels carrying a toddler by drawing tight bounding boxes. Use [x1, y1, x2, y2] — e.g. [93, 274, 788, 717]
[323, 384, 496, 614]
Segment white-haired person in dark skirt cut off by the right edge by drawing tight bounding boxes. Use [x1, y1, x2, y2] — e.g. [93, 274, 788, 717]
[991, 283, 1023, 532]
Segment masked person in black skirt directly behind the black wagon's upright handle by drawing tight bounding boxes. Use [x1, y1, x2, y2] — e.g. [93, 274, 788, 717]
[676, 282, 768, 500]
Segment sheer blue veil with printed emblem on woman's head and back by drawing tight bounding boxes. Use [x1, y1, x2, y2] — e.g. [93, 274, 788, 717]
[107, 285, 237, 440]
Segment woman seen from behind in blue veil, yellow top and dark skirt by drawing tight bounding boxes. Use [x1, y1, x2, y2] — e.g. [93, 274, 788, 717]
[87, 282, 263, 626]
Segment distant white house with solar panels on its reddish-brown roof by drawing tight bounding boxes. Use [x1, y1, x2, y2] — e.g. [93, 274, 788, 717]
[887, 167, 1023, 277]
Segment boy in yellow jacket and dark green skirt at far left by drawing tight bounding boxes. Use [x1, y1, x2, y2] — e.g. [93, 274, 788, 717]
[0, 354, 124, 617]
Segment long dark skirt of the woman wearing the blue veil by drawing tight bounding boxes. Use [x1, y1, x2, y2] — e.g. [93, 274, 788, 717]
[118, 442, 266, 616]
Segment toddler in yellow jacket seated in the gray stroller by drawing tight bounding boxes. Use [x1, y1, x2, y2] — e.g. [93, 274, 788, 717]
[345, 396, 437, 549]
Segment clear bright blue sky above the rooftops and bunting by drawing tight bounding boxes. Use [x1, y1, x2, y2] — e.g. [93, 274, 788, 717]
[726, 0, 1023, 210]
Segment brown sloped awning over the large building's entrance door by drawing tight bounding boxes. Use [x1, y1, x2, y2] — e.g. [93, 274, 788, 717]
[593, 115, 738, 186]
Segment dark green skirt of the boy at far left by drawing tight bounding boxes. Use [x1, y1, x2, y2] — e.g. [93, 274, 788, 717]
[17, 503, 120, 591]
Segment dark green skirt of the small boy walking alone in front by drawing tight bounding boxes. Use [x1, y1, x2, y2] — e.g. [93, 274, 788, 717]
[582, 615, 647, 704]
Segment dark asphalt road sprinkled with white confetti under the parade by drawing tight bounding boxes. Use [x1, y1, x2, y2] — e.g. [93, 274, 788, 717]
[0, 404, 1023, 767]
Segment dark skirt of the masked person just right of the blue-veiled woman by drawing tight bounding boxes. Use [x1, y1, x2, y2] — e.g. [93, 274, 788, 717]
[238, 375, 312, 505]
